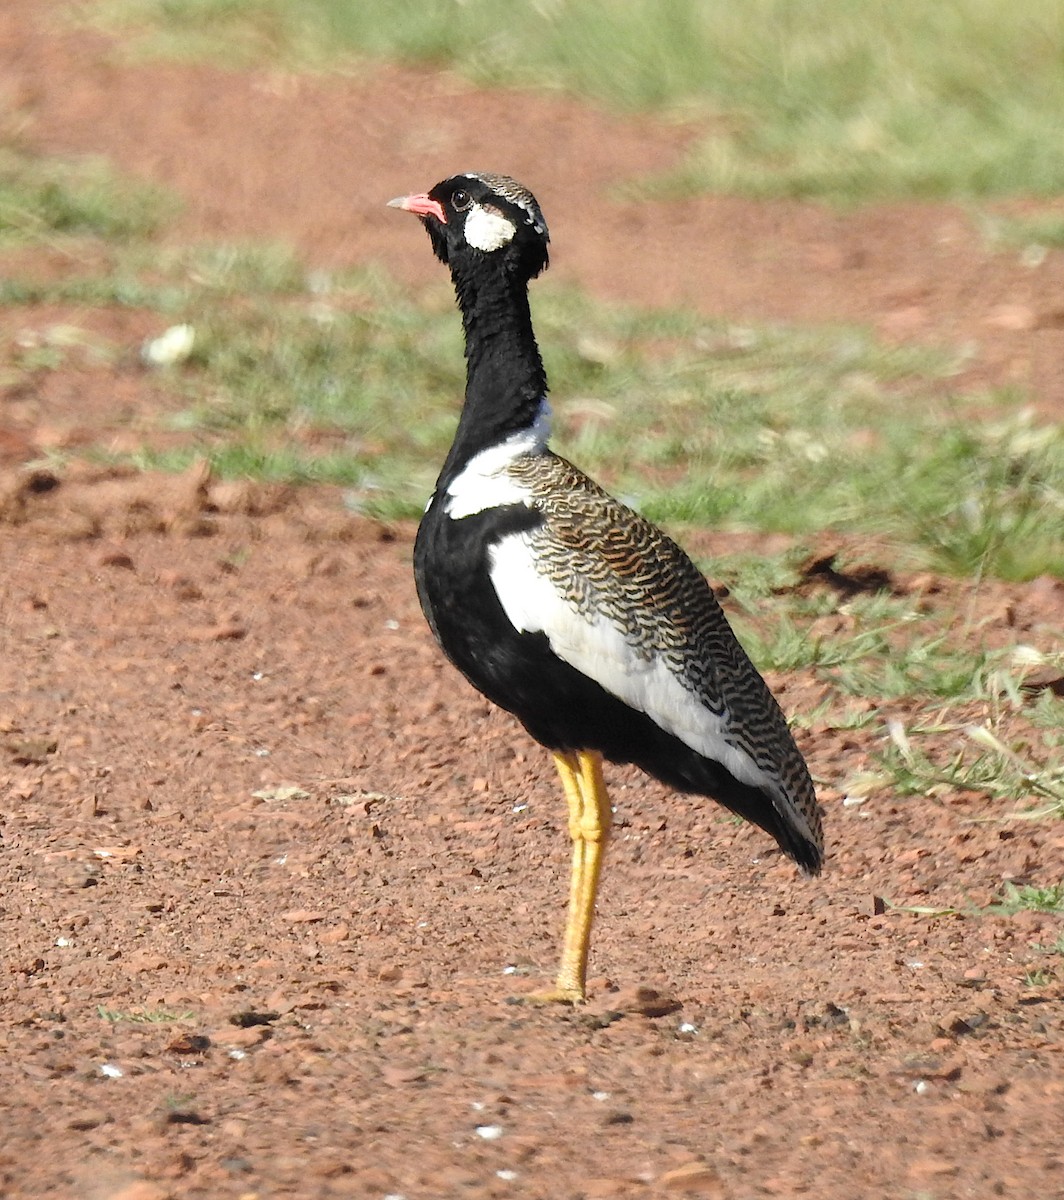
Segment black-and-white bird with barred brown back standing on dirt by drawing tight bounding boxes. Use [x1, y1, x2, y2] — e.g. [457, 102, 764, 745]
[390, 172, 823, 1003]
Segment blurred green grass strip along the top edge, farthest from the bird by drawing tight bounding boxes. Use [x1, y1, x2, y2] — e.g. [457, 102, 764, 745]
[78, 0, 1064, 202]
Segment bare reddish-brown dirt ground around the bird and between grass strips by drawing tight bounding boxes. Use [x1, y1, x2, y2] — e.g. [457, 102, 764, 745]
[0, 0, 1064, 1200]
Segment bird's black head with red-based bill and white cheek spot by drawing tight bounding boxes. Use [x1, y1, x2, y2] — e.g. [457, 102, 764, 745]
[389, 172, 551, 280]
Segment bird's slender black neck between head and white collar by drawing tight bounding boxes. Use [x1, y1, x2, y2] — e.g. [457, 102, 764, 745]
[444, 256, 547, 474]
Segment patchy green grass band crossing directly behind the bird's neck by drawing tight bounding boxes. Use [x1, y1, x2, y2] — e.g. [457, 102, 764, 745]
[10, 229, 1064, 576]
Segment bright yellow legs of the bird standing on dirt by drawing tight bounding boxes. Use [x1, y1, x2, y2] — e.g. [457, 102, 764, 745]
[530, 750, 613, 1004]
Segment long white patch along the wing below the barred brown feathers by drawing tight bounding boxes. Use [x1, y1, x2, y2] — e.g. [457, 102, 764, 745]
[489, 533, 779, 792]
